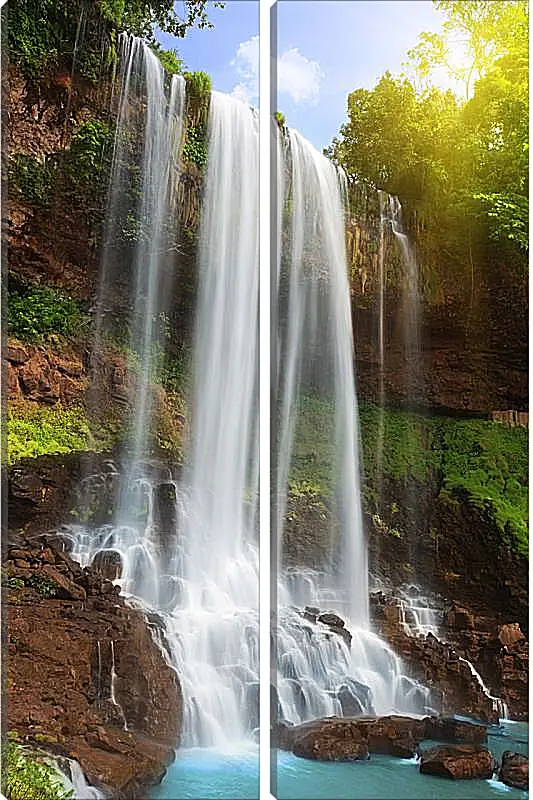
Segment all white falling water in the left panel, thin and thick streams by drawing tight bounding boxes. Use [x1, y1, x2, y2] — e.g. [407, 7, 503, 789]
[64, 38, 259, 760]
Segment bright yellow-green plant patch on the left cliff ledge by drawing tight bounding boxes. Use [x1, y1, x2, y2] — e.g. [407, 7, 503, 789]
[7, 402, 91, 464]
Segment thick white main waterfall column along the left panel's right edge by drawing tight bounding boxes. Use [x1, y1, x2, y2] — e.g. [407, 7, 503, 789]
[164, 92, 259, 745]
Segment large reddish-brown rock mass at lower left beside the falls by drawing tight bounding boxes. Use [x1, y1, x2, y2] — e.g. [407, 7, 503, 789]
[6, 537, 181, 798]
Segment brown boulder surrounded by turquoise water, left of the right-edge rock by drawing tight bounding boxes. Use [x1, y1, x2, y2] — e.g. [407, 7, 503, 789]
[420, 744, 494, 780]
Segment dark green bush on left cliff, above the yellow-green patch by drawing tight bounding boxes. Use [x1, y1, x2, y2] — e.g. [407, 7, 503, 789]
[8, 281, 85, 342]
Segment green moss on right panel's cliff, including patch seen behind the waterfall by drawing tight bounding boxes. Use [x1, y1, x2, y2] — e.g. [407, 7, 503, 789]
[290, 395, 529, 556]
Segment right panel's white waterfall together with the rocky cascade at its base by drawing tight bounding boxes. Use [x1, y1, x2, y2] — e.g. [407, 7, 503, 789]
[274, 131, 429, 722]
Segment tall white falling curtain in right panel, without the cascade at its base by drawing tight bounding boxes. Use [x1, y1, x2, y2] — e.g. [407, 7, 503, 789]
[277, 130, 368, 623]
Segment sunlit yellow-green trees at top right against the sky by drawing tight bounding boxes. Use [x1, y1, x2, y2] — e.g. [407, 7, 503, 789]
[327, 0, 529, 269]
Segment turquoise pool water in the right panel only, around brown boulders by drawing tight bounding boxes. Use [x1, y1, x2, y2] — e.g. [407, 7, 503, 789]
[273, 723, 528, 800]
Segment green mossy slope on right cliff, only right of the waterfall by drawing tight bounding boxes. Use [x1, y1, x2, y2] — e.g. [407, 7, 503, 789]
[360, 405, 529, 555]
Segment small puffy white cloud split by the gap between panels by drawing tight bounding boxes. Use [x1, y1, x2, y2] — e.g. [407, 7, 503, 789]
[230, 36, 324, 103]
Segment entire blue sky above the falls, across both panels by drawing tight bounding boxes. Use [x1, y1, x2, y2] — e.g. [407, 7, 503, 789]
[159, 0, 449, 149]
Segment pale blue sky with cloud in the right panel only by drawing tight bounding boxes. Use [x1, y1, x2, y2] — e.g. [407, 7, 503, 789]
[277, 0, 450, 149]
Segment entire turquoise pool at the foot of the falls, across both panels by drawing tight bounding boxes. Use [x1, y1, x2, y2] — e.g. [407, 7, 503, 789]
[152, 723, 528, 800]
